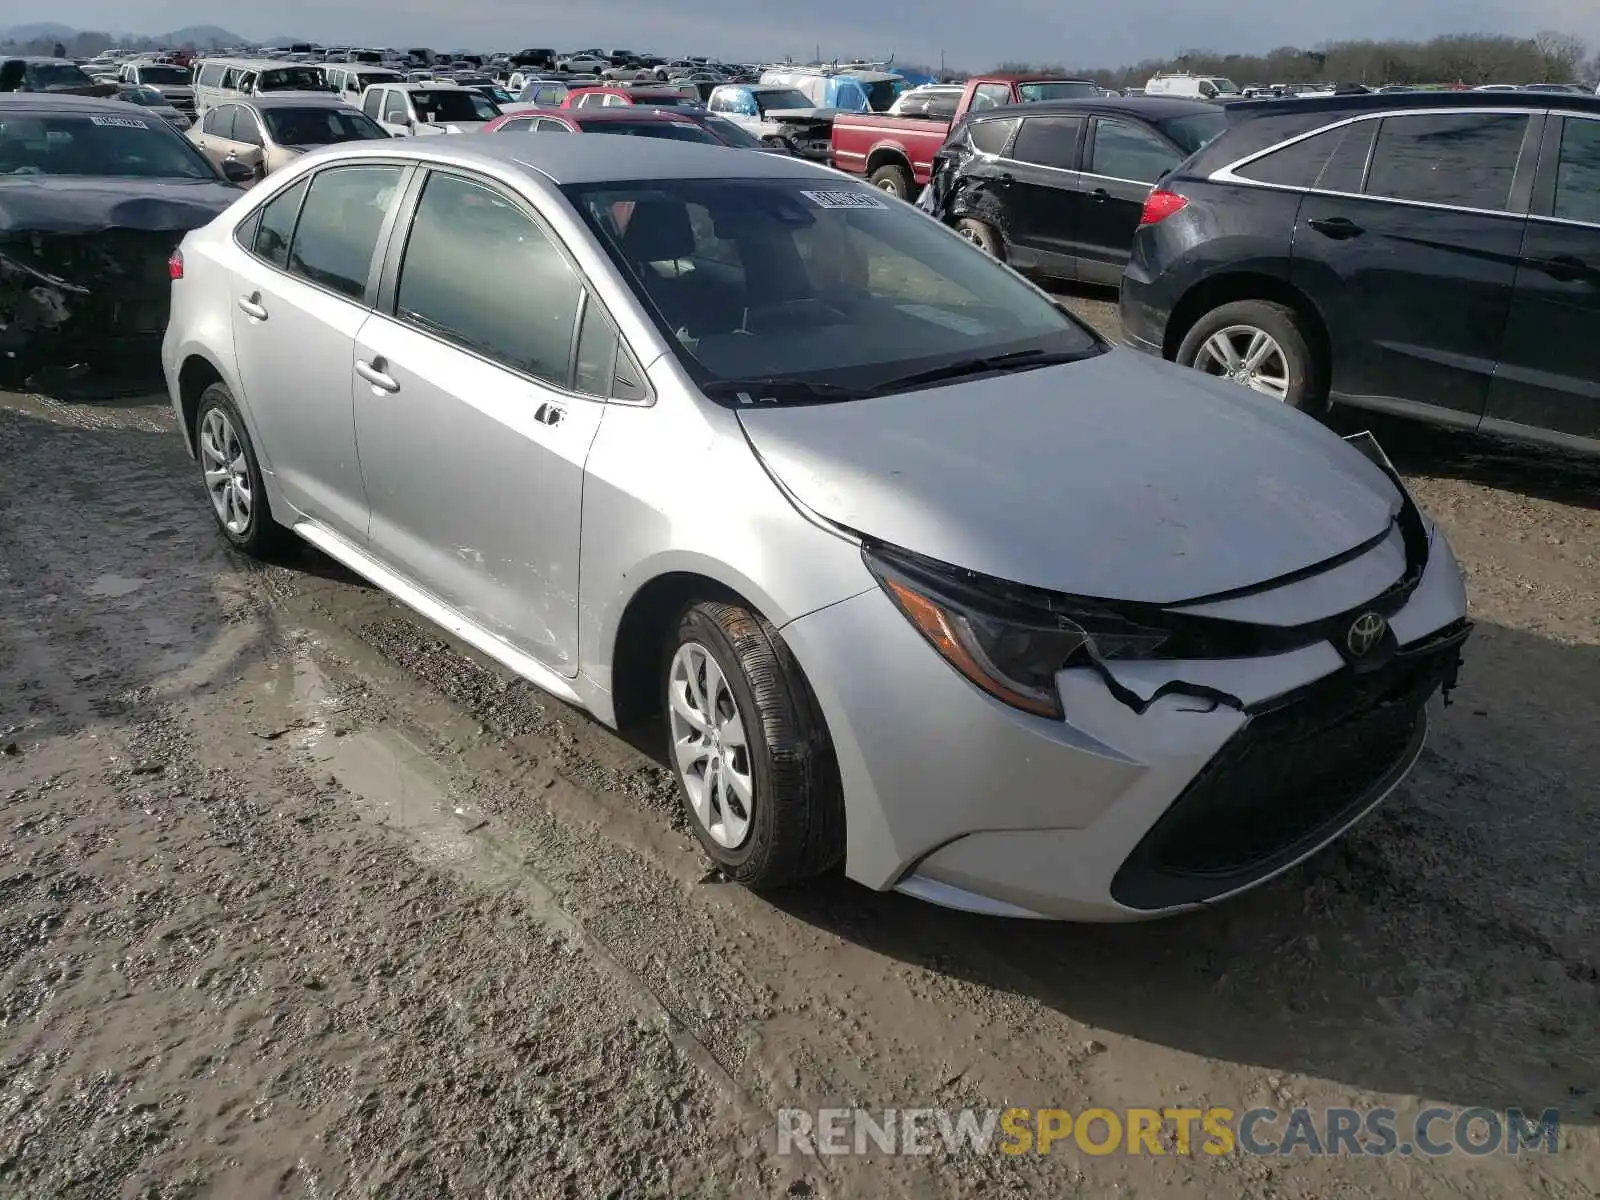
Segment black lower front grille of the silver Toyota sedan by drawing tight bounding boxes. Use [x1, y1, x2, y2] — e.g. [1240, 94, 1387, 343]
[1110, 621, 1470, 909]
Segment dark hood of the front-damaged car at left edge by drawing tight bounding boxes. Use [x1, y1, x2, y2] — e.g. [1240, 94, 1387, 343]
[0, 174, 240, 237]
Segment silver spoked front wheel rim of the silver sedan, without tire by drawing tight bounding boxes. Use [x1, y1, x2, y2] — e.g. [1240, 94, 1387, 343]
[667, 642, 755, 850]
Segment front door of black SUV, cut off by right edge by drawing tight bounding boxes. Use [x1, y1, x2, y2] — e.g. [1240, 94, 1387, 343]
[1483, 114, 1600, 450]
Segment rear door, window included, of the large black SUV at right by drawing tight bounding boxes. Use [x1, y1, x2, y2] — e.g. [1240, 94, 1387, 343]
[1291, 109, 1542, 427]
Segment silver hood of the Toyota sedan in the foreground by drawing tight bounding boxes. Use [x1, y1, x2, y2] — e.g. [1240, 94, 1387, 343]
[739, 349, 1402, 603]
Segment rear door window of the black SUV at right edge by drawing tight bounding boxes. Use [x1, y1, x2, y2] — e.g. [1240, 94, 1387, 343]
[1366, 112, 1528, 211]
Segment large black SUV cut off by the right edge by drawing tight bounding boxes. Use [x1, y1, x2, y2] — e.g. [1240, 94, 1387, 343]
[1122, 93, 1600, 453]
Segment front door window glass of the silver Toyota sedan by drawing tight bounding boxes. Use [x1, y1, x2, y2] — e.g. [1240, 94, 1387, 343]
[395, 174, 582, 387]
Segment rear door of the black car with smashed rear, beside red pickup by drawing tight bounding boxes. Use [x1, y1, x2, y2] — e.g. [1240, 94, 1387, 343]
[997, 117, 1086, 278]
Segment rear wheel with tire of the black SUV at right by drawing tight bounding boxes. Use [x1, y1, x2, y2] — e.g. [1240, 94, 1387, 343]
[1178, 299, 1328, 416]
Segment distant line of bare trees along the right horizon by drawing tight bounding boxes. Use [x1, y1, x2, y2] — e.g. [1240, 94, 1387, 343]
[923, 30, 1600, 88]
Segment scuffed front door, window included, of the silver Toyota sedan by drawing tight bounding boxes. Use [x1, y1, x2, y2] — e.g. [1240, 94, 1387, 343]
[349, 171, 610, 677]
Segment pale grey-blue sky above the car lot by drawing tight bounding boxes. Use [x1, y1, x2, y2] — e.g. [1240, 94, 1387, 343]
[6, 0, 1600, 69]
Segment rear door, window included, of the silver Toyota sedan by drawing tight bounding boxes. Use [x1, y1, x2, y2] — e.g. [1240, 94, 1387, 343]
[232, 165, 405, 544]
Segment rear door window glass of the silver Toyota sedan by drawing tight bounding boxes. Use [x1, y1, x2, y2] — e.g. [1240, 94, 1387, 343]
[288, 166, 400, 299]
